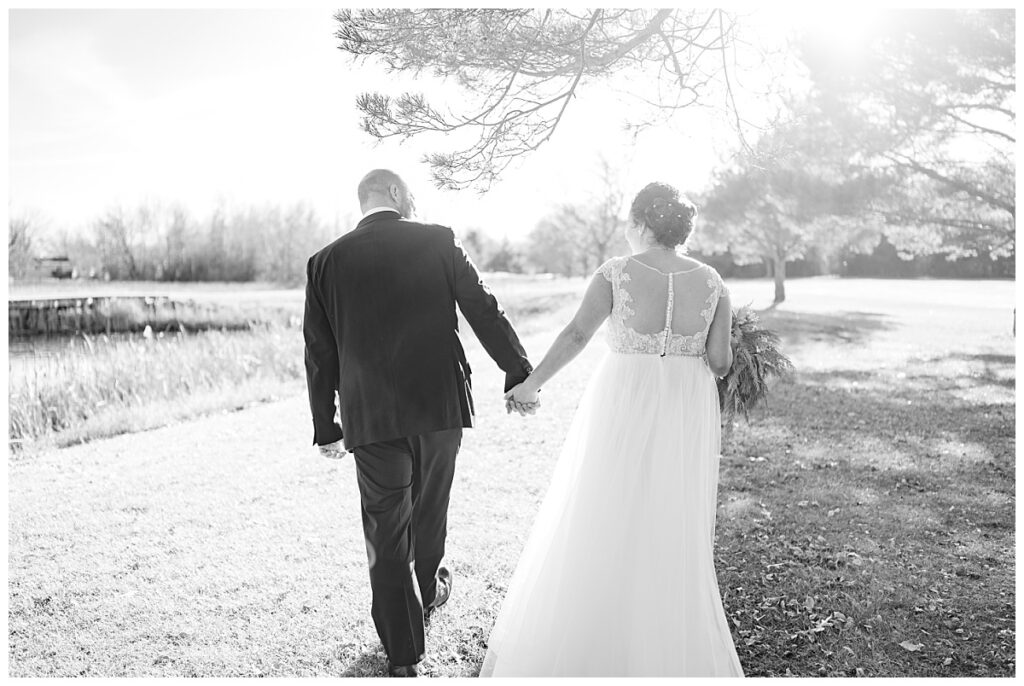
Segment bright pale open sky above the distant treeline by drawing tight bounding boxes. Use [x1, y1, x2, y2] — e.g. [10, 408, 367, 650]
[8, 9, 806, 240]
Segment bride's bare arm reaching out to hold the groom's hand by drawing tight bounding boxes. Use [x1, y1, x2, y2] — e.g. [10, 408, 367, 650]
[511, 272, 611, 402]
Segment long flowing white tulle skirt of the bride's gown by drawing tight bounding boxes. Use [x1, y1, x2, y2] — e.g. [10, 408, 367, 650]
[480, 352, 742, 677]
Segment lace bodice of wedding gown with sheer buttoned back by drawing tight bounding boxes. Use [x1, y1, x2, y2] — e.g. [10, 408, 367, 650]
[598, 256, 726, 356]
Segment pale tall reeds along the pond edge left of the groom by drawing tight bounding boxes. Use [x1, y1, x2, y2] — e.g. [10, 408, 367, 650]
[9, 325, 303, 445]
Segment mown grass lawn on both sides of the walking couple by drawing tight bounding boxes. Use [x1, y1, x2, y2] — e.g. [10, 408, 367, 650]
[8, 278, 1015, 677]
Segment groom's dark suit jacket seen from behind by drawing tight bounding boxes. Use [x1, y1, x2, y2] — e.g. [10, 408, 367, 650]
[302, 212, 532, 449]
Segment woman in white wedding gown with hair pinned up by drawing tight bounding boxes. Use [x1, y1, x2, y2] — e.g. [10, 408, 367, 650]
[480, 183, 742, 677]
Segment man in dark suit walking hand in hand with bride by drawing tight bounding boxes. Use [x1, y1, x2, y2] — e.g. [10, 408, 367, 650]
[302, 169, 532, 677]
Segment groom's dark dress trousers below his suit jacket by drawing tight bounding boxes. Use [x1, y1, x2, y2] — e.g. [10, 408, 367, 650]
[352, 429, 462, 664]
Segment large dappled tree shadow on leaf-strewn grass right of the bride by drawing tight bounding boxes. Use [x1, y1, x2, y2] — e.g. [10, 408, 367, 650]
[717, 355, 1015, 677]
